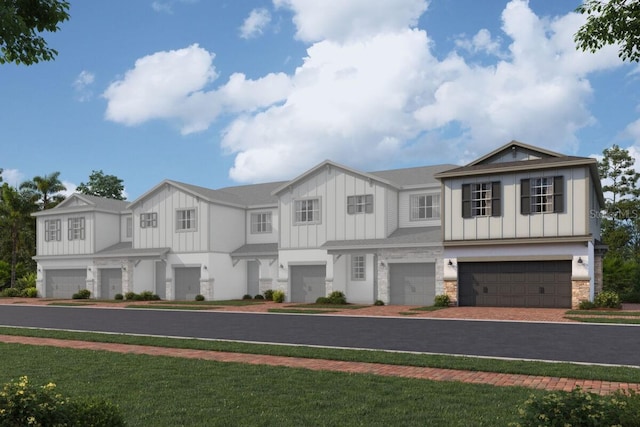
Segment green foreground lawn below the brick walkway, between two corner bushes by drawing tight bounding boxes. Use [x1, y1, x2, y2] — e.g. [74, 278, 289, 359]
[0, 344, 541, 426]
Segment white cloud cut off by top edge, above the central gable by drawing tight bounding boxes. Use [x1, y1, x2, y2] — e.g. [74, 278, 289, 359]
[273, 0, 428, 42]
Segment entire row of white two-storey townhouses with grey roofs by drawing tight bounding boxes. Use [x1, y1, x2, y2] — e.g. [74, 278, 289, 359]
[34, 141, 604, 307]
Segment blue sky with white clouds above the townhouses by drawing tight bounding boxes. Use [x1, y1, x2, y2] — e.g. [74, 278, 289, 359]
[0, 0, 640, 200]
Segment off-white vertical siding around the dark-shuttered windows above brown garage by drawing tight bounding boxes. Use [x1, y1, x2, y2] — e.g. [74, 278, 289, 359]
[441, 168, 590, 241]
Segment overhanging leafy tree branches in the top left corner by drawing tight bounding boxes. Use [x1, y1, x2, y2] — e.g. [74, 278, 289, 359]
[0, 0, 69, 65]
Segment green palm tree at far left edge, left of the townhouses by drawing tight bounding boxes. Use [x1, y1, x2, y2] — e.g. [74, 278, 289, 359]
[0, 183, 38, 288]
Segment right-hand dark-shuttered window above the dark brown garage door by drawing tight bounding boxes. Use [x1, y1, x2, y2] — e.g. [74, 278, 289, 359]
[520, 176, 564, 215]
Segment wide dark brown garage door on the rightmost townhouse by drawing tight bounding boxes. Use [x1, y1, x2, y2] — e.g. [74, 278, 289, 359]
[458, 261, 571, 308]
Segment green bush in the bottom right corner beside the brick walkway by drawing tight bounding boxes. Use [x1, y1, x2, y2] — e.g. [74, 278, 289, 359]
[510, 387, 640, 427]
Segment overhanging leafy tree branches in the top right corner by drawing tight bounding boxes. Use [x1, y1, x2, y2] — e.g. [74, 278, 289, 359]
[574, 0, 640, 62]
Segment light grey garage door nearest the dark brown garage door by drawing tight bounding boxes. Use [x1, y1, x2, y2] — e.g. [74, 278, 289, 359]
[389, 263, 436, 305]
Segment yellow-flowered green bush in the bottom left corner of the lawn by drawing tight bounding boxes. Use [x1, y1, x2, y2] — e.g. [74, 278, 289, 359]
[0, 376, 125, 427]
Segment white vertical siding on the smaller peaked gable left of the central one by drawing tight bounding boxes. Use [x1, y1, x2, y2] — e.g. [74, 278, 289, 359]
[133, 185, 210, 252]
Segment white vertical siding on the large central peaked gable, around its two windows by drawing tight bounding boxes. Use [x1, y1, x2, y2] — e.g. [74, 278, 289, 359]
[279, 167, 389, 248]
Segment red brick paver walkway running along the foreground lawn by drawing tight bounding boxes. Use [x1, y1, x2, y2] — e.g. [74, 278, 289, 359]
[0, 335, 640, 394]
